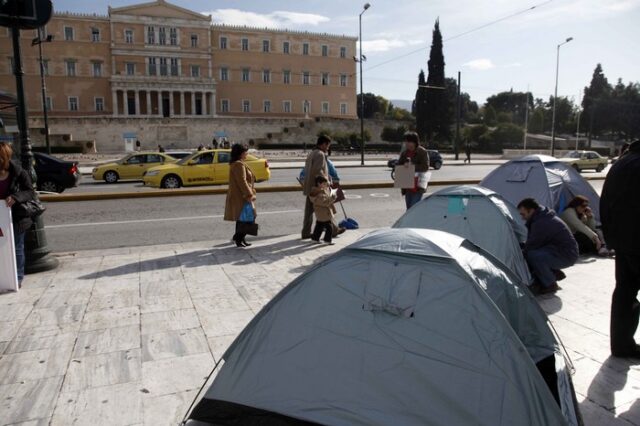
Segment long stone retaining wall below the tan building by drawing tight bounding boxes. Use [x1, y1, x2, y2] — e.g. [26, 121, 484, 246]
[30, 117, 403, 153]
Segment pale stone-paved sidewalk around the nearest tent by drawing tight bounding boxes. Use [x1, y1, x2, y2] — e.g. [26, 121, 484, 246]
[0, 231, 640, 426]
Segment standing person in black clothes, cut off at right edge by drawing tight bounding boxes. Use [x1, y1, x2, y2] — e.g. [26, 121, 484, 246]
[600, 140, 640, 358]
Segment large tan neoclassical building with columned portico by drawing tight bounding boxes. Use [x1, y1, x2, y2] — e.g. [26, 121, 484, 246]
[0, 0, 357, 123]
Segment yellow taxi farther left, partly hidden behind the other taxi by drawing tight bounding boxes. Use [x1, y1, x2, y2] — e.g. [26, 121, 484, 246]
[91, 152, 178, 183]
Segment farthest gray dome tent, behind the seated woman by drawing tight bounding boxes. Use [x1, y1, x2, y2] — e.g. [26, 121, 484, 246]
[480, 155, 600, 223]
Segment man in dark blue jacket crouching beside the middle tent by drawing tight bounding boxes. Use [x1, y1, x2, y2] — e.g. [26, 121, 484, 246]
[518, 198, 578, 294]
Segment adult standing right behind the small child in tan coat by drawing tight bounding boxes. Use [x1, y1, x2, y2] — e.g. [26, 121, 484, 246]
[302, 135, 331, 240]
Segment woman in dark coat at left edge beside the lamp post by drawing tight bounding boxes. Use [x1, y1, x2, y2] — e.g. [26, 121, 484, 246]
[0, 143, 35, 286]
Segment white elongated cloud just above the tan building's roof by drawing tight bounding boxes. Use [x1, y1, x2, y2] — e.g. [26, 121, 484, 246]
[205, 9, 329, 28]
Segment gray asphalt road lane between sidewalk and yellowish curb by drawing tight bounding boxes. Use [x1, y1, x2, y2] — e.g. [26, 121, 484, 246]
[44, 180, 603, 252]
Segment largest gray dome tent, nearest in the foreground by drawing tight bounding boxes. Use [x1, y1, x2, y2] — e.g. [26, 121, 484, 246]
[187, 229, 577, 426]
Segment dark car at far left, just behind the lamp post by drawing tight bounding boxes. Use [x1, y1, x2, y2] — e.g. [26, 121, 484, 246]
[33, 152, 80, 192]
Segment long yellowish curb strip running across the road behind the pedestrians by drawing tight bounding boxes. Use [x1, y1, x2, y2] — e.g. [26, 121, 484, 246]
[40, 176, 604, 203]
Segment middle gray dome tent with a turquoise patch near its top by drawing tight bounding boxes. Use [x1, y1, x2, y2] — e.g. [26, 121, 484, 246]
[393, 185, 531, 285]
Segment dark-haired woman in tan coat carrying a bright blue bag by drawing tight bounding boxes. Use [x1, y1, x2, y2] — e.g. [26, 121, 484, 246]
[224, 144, 256, 247]
